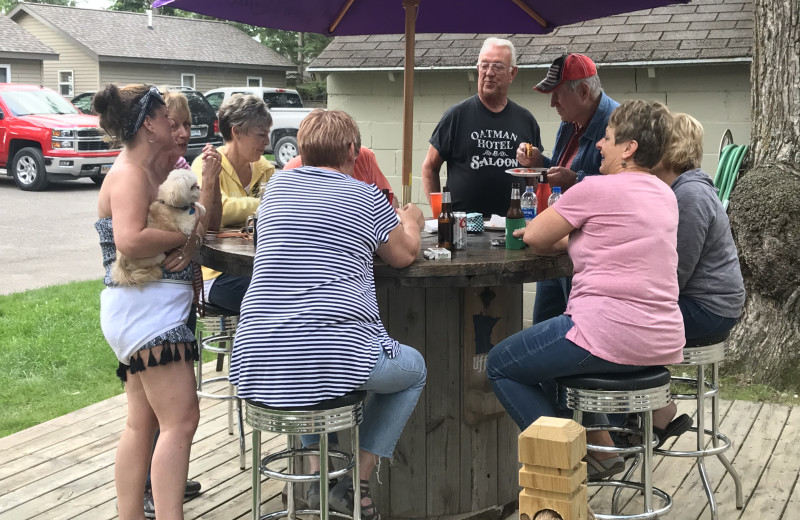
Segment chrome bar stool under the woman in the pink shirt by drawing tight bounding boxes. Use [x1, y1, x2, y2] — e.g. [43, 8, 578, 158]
[556, 367, 672, 520]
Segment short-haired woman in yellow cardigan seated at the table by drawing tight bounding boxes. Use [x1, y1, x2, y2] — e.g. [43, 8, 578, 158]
[192, 94, 275, 313]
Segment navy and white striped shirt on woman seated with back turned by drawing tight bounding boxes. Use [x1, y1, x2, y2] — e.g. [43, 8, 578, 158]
[231, 167, 399, 407]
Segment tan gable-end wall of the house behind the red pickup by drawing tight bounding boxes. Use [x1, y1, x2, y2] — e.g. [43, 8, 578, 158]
[15, 13, 99, 95]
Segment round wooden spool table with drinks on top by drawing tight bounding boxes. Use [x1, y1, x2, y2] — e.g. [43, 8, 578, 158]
[200, 232, 572, 519]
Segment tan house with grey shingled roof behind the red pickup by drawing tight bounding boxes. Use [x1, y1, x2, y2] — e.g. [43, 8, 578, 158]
[7, 3, 296, 98]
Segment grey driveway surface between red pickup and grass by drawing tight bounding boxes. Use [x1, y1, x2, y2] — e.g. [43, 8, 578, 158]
[0, 176, 103, 294]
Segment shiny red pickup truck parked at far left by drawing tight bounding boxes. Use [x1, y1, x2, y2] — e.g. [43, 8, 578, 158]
[0, 83, 120, 191]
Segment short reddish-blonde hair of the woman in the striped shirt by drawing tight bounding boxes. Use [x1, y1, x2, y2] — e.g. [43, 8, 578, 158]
[297, 108, 361, 167]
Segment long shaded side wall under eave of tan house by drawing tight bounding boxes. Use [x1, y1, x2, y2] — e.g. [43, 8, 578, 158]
[100, 62, 286, 92]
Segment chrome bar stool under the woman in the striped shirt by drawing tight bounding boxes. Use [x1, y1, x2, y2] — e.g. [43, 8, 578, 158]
[245, 391, 367, 520]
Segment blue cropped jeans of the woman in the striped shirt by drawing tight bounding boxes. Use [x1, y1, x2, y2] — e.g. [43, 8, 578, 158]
[302, 344, 427, 458]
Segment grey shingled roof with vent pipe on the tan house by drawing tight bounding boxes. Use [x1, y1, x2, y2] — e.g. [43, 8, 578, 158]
[9, 4, 296, 70]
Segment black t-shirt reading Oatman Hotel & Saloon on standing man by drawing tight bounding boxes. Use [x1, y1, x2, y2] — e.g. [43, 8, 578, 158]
[430, 94, 542, 217]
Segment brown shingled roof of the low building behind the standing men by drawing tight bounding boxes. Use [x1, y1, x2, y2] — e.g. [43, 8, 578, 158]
[308, 0, 753, 72]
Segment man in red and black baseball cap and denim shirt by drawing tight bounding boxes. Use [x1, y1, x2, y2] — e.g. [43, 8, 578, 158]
[517, 54, 619, 323]
